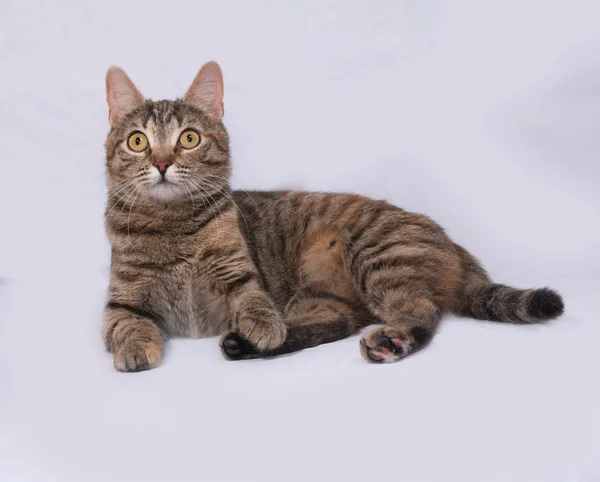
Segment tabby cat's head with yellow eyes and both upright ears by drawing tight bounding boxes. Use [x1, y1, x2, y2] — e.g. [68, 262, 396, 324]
[106, 62, 230, 202]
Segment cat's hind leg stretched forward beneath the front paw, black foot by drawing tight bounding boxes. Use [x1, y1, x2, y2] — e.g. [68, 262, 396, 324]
[220, 288, 373, 360]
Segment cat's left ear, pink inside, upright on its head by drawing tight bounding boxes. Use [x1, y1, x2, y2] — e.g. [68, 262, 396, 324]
[106, 67, 144, 127]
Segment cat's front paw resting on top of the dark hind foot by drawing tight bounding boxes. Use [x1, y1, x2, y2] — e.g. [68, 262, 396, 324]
[237, 312, 287, 351]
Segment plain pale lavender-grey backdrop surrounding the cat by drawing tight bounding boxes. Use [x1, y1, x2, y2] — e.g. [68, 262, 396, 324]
[0, 0, 600, 482]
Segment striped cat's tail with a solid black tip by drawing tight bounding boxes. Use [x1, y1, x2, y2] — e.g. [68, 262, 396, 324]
[456, 283, 564, 324]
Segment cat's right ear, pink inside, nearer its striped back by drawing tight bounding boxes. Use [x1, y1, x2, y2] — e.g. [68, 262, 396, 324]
[183, 62, 223, 121]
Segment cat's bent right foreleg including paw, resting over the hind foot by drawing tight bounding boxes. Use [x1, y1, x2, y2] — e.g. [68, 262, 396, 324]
[230, 279, 287, 351]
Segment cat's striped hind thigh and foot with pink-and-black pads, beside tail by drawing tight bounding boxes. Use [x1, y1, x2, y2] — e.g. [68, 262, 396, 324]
[357, 239, 448, 363]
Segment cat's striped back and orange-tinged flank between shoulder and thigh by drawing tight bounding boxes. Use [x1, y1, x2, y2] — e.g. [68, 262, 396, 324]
[233, 191, 454, 308]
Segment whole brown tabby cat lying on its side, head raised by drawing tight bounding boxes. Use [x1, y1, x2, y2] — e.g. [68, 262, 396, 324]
[103, 62, 564, 372]
